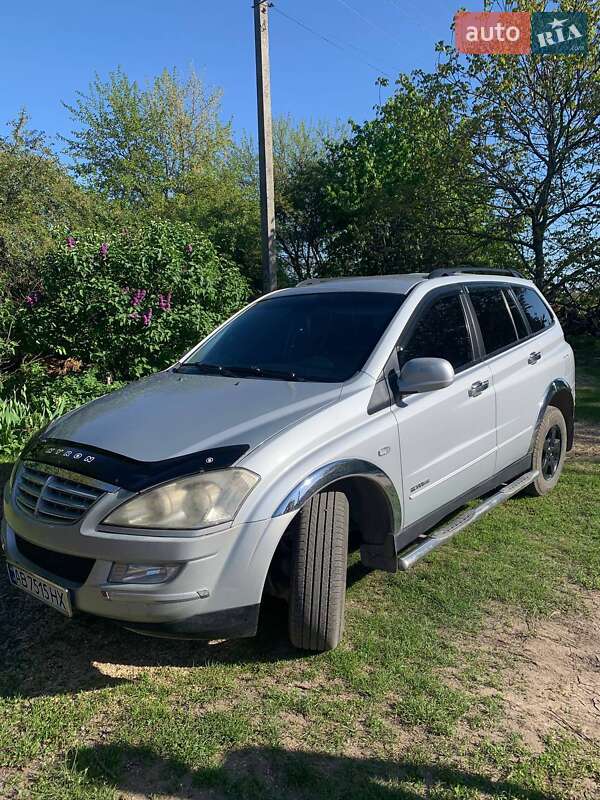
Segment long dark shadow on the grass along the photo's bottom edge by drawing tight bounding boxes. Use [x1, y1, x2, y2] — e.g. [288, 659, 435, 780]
[68, 744, 552, 800]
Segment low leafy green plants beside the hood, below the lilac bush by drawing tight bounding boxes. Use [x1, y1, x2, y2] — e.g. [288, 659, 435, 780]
[0, 363, 124, 459]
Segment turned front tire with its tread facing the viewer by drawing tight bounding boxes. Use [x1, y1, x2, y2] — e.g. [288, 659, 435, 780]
[289, 491, 349, 652]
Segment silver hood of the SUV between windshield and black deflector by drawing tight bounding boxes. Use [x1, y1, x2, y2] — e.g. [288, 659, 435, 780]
[44, 372, 341, 461]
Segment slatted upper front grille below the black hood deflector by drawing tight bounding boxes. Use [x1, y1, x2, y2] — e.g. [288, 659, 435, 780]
[15, 464, 104, 525]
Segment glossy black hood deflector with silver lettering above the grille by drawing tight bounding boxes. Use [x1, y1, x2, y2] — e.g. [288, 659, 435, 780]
[21, 437, 249, 492]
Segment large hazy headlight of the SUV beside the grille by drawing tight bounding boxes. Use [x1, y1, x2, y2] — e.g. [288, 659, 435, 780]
[104, 469, 259, 530]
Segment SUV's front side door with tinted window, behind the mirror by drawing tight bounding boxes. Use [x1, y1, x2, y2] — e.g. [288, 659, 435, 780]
[394, 287, 496, 527]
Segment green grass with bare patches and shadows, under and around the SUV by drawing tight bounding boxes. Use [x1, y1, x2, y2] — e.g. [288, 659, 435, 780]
[0, 340, 600, 800]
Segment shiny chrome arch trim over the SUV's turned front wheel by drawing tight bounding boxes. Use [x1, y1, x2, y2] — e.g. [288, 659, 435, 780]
[273, 458, 402, 531]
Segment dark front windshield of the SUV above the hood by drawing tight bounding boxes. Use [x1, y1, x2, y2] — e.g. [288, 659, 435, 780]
[179, 292, 404, 383]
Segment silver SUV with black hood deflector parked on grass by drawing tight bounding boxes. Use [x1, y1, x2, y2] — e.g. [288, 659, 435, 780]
[2, 269, 575, 650]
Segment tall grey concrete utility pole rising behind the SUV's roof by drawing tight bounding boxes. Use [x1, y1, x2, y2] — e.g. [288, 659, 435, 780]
[254, 0, 277, 294]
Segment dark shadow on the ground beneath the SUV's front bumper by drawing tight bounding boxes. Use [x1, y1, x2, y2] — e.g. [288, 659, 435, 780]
[0, 559, 376, 697]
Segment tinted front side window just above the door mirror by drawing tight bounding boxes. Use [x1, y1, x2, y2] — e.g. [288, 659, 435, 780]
[398, 294, 473, 370]
